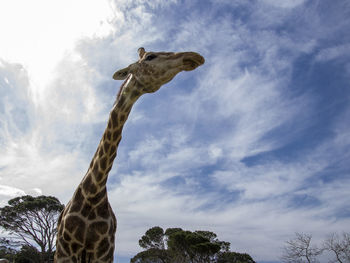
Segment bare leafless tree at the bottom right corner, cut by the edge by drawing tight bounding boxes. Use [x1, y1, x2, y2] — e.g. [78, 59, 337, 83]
[323, 233, 350, 263]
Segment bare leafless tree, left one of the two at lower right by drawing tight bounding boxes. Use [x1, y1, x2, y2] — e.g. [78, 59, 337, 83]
[282, 233, 322, 263]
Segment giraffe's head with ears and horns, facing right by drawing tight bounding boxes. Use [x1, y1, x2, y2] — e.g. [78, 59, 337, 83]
[113, 47, 204, 93]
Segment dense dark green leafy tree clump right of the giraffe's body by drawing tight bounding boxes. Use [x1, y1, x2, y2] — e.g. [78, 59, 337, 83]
[130, 227, 255, 263]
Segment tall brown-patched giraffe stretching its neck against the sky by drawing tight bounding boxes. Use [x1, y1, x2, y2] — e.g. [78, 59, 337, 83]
[55, 48, 204, 263]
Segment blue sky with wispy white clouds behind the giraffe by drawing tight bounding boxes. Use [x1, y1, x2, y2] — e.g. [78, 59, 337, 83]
[0, 0, 350, 263]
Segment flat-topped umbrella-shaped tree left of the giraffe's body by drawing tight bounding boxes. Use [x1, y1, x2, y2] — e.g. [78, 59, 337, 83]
[0, 195, 64, 262]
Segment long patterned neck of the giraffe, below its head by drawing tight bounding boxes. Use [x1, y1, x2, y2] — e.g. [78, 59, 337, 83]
[73, 75, 142, 205]
